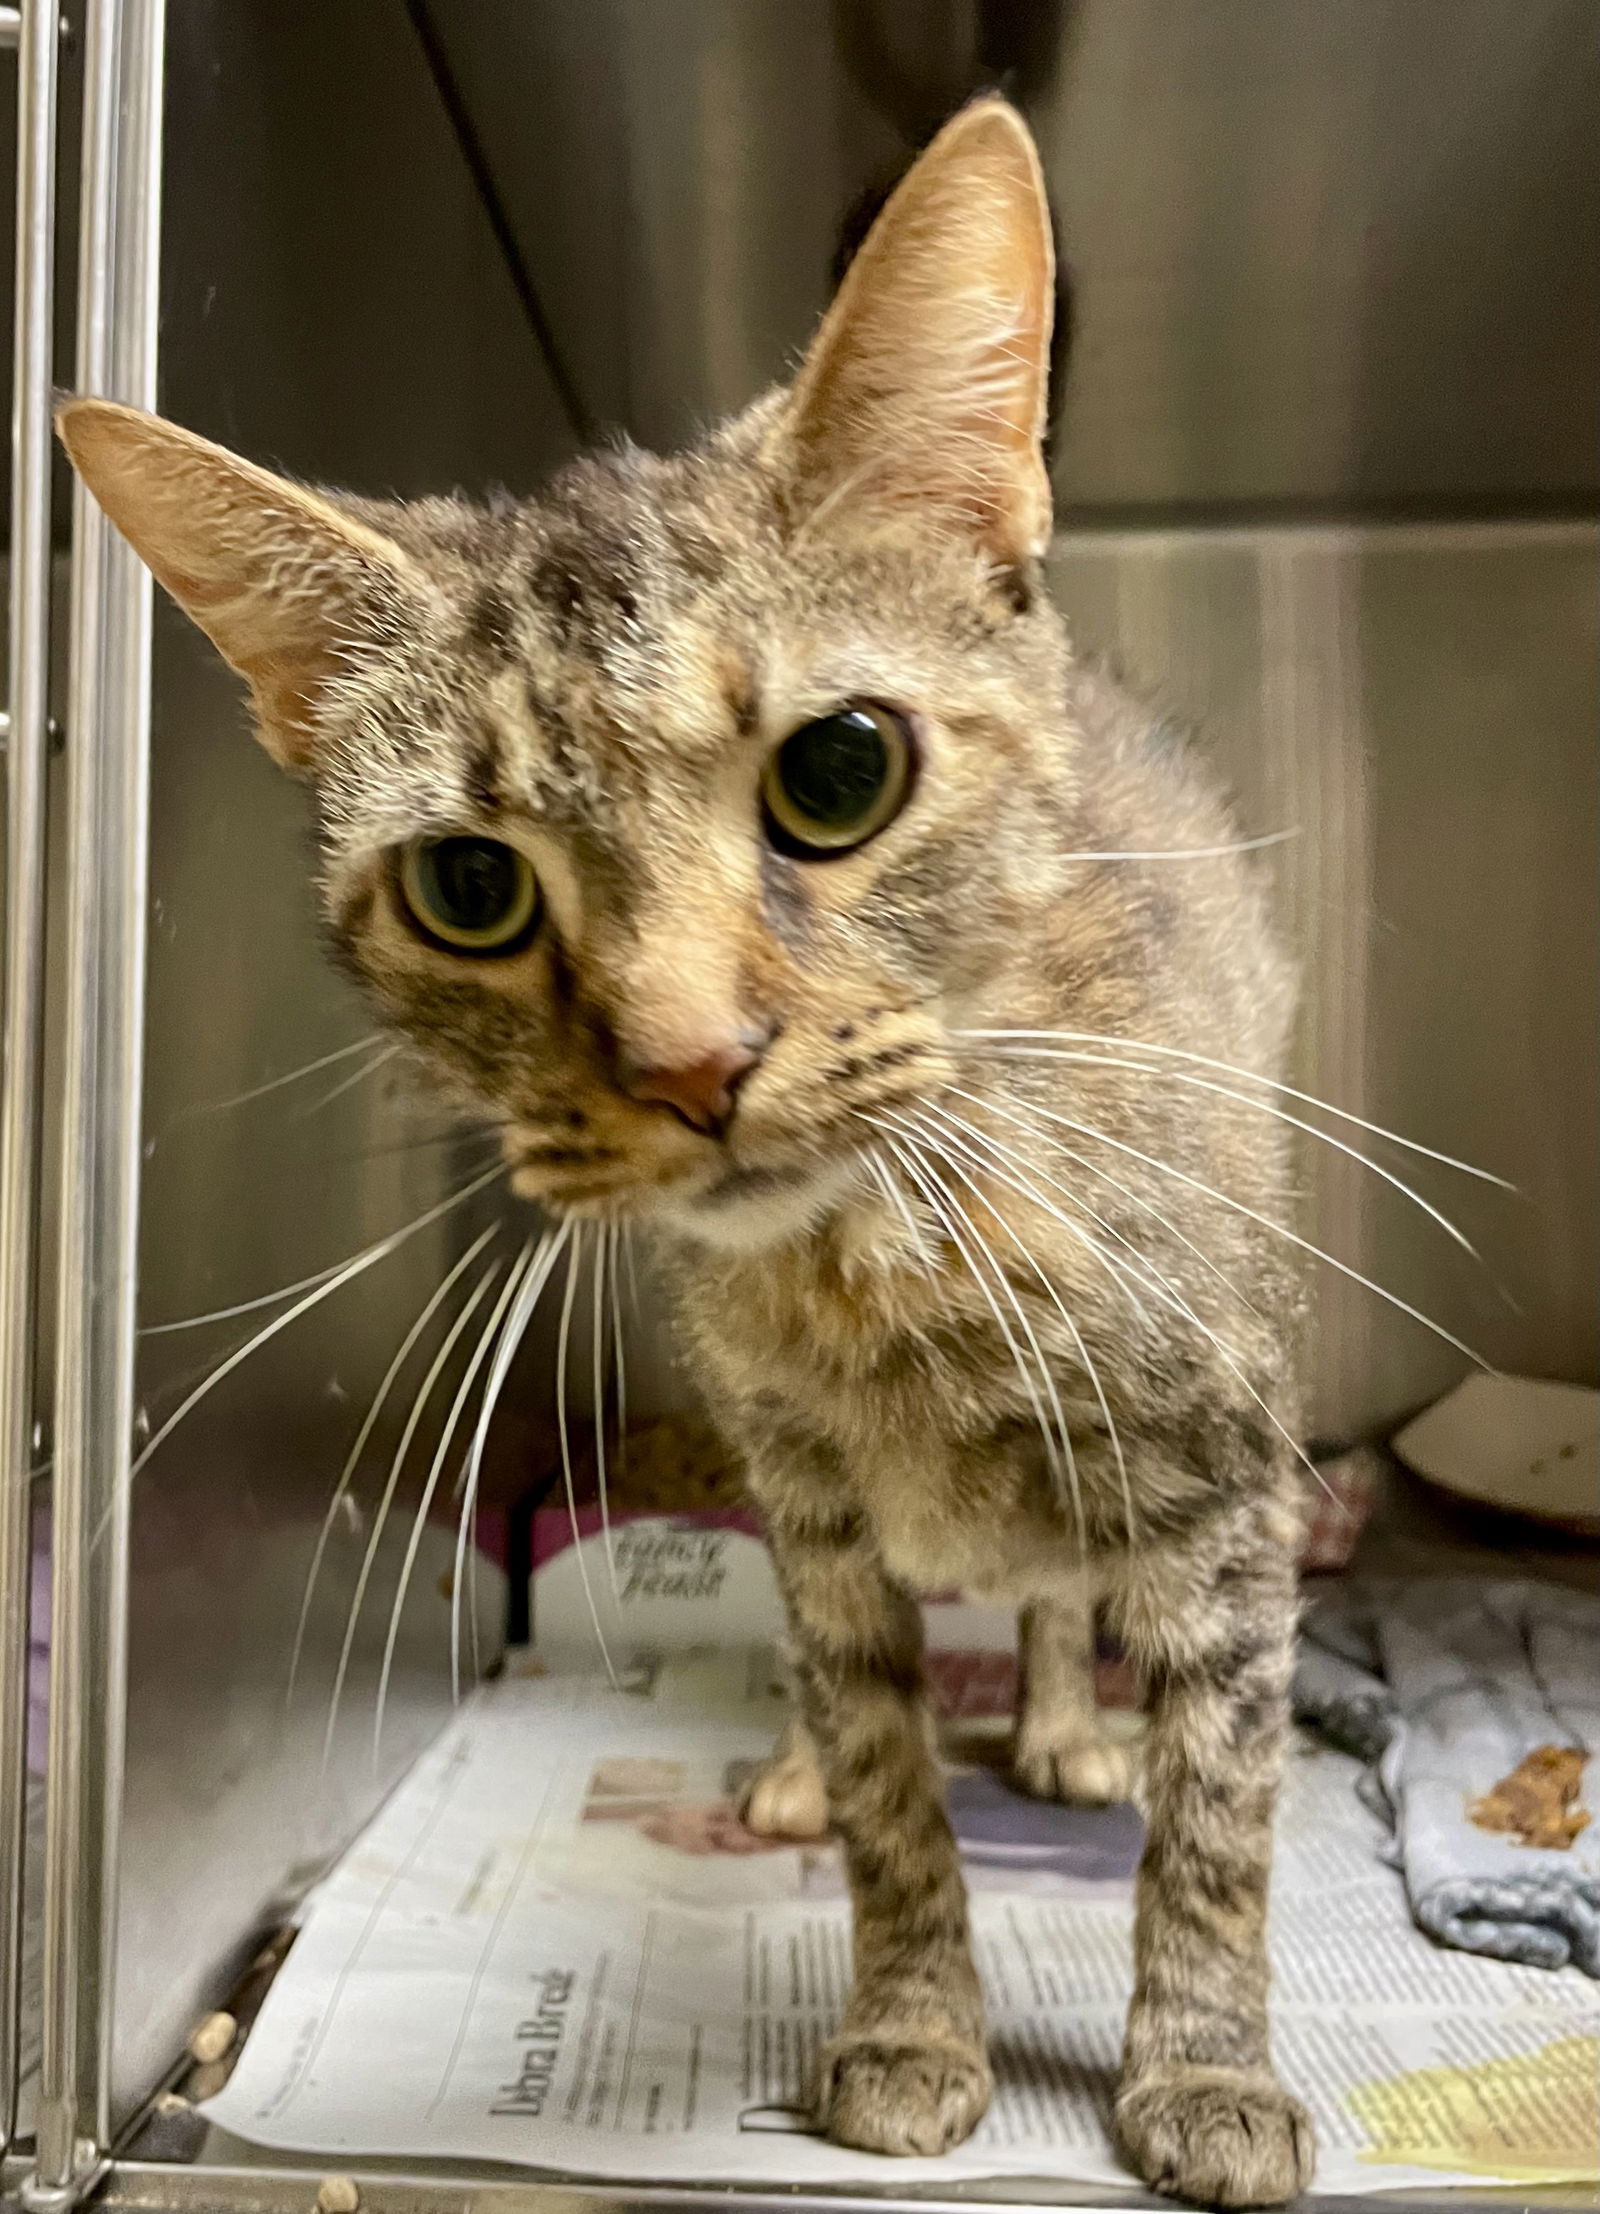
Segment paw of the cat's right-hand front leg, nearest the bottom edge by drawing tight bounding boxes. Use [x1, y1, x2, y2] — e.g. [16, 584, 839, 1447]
[1118, 2068, 1317, 2207]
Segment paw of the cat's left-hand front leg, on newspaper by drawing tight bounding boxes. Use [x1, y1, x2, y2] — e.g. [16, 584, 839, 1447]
[817, 2030, 994, 2156]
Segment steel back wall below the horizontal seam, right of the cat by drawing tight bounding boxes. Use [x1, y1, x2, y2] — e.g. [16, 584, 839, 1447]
[1053, 523, 1600, 1439]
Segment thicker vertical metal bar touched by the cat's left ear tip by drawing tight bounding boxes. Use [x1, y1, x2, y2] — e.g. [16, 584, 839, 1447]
[29, 0, 164, 2207]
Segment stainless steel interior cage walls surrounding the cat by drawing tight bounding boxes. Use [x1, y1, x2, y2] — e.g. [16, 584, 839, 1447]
[6, 0, 1600, 2143]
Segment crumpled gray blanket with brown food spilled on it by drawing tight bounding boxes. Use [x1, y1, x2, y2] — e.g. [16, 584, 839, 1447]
[1295, 1579, 1600, 1977]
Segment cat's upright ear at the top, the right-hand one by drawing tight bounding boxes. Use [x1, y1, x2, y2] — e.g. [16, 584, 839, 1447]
[783, 100, 1056, 569]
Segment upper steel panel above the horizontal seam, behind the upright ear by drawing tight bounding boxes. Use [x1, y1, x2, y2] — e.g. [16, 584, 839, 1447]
[434, 0, 1600, 518]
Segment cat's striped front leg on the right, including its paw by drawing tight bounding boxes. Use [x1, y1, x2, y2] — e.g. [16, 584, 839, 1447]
[1115, 1499, 1315, 2207]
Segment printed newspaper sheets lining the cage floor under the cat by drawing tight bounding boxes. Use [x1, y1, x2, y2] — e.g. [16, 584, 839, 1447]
[208, 1656, 1600, 2192]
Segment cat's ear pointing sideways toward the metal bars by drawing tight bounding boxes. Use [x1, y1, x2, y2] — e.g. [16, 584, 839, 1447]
[55, 401, 427, 775]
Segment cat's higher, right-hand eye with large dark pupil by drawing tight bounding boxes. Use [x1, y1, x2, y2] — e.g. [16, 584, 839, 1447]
[761, 702, 912, 861]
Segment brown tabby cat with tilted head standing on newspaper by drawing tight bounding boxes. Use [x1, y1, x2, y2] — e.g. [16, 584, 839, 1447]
[60, 100, 1312, 2205]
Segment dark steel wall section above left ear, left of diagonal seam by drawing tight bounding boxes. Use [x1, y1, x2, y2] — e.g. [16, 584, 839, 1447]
[162, 0, 571, 494]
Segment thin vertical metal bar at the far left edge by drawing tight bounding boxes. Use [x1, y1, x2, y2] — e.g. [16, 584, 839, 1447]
[0, 0, 60, 2148]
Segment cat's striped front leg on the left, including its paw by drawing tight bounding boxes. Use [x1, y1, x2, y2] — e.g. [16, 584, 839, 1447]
[755, 1457, 989, 2154]
